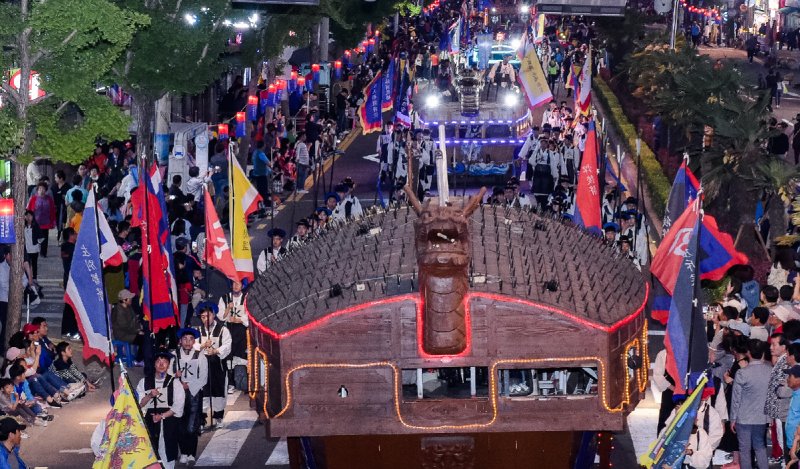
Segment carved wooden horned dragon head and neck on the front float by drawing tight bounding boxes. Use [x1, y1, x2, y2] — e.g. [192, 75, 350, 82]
[405, 186, 486, 355]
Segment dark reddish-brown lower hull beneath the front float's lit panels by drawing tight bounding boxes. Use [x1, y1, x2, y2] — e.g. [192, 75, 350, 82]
[289, 432, 581, 469]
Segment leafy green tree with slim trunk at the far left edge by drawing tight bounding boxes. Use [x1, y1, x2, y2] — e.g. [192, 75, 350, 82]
[0, 0, 147, 337]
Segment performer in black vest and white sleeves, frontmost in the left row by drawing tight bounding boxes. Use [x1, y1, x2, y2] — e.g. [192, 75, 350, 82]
[136, 351, 186, 469]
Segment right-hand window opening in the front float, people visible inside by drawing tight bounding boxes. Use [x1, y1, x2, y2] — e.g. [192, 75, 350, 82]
[497, 366, 598, 399]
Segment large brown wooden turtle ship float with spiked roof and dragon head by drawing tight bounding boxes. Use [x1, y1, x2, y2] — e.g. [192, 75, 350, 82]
[246, 187, 648, 469]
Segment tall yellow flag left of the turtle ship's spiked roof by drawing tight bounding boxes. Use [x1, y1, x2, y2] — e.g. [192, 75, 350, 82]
[228, 153, 264, 282]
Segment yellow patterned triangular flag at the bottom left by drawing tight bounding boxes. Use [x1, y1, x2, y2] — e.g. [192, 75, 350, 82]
[92, 374, 161, 469]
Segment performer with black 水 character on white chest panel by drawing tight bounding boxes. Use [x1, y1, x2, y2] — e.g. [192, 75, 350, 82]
[172, 327, 208, 464]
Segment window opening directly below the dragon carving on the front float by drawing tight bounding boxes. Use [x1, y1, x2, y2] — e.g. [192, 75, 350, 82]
[402, 366, 489, 401]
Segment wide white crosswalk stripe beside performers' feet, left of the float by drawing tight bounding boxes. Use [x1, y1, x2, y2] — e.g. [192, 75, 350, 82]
[195, 410, 258, 466]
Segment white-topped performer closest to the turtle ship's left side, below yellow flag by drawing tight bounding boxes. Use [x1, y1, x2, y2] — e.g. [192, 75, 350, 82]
[217, 281, 250, 394]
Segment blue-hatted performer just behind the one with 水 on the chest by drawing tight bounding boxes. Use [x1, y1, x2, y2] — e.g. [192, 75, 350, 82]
[198, 302, 231, 428]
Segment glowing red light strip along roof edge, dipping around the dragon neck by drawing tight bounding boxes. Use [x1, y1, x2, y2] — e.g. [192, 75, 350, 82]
[244, 282, 650, 340]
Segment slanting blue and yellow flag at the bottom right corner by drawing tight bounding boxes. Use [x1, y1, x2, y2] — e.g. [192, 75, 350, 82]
[639, 376, 708, 469]
